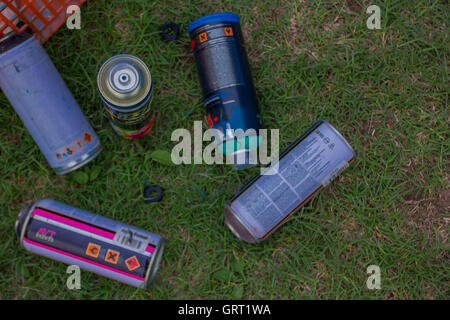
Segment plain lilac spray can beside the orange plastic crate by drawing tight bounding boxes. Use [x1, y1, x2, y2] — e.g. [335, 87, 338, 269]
[0, 33, 102, 174]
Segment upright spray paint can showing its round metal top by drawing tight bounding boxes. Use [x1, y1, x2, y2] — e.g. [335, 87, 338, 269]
[97, 54, 155, 139]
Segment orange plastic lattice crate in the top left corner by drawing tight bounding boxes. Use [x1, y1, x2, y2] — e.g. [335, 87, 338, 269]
[0, 0, 86, 42]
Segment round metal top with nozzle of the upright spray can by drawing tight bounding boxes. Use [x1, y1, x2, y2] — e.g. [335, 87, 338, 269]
[97, 54, 152, 107]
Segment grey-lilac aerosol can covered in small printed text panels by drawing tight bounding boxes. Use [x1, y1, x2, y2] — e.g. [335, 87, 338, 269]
[225, 120, 356, 242]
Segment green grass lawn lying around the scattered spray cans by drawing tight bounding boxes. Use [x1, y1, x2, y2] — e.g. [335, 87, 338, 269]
[0, 0, 450, 299]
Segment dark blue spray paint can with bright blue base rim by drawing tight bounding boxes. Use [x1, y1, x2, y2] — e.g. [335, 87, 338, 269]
[188, 13, 262, 169]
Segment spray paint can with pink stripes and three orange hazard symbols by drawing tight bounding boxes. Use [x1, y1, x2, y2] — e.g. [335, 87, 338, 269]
[15, 199, 165, 289]
